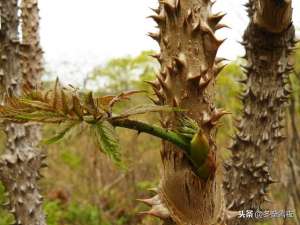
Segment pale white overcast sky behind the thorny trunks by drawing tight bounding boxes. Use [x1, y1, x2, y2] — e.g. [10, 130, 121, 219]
[39, 0, 300, 85]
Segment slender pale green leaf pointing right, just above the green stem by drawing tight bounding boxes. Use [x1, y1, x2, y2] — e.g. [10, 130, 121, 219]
[114, 104, 184, 119]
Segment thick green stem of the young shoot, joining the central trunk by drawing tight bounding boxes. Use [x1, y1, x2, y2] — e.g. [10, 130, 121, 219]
[110, 119, 190, 153]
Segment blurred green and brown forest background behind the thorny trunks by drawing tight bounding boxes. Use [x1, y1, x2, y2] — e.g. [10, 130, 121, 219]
[0, 43, 300, 225]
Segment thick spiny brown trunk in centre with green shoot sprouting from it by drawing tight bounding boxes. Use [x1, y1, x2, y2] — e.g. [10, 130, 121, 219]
[142, 0, 229, 225]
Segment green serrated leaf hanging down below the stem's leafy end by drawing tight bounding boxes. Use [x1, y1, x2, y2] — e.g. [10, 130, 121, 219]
[93, 120, 122, 167]
